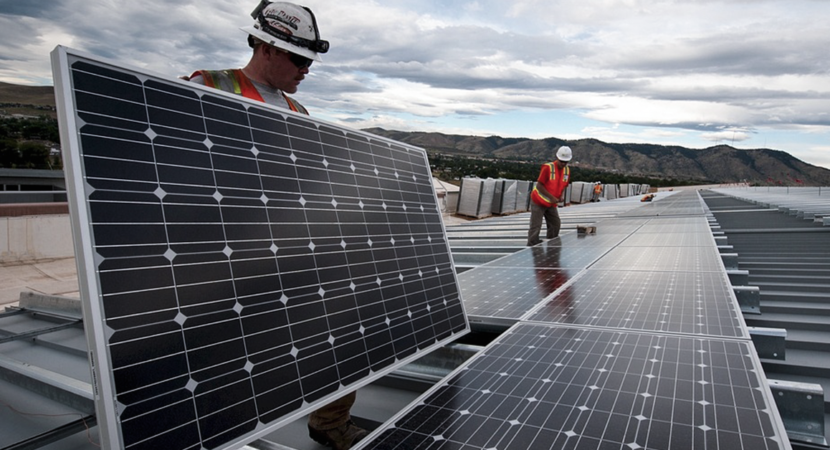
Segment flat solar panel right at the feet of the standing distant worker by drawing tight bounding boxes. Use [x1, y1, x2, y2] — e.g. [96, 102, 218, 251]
[483, 244, 610, 269]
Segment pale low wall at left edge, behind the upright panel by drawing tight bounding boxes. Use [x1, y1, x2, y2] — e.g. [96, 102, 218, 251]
[0, 214, 75, 264]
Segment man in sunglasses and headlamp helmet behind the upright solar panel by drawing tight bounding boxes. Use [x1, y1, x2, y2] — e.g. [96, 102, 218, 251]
[189, 0, 367, 450]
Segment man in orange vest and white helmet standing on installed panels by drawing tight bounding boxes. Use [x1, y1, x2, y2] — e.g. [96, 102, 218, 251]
[527, 146, 573, 247]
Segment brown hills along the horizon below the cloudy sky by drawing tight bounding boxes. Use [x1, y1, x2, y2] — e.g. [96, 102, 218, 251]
[0, 82, 830, 186]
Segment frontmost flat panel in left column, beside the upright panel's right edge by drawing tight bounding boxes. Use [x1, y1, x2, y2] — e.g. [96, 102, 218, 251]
[458, 267, 575, 321]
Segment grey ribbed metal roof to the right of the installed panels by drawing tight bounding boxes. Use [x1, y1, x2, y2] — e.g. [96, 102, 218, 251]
[703, 188, 830, 450]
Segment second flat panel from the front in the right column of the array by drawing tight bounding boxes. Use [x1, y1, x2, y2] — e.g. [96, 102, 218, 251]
[528, 270, 748, 338]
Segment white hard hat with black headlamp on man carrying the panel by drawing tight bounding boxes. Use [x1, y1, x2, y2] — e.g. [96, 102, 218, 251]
[240, 0, 329, 61]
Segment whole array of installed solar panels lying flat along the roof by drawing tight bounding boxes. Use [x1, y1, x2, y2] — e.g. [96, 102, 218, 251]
[360, 192, 790, 450]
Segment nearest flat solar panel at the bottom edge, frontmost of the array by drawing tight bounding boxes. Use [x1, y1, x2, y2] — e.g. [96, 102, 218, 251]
[359, 323, 789, 450]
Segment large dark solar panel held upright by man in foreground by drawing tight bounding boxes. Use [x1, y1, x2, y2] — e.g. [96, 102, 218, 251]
[52, 47, 468, 449]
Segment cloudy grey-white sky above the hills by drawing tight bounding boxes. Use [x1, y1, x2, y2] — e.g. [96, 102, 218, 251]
[0, 0, 830, 168]
